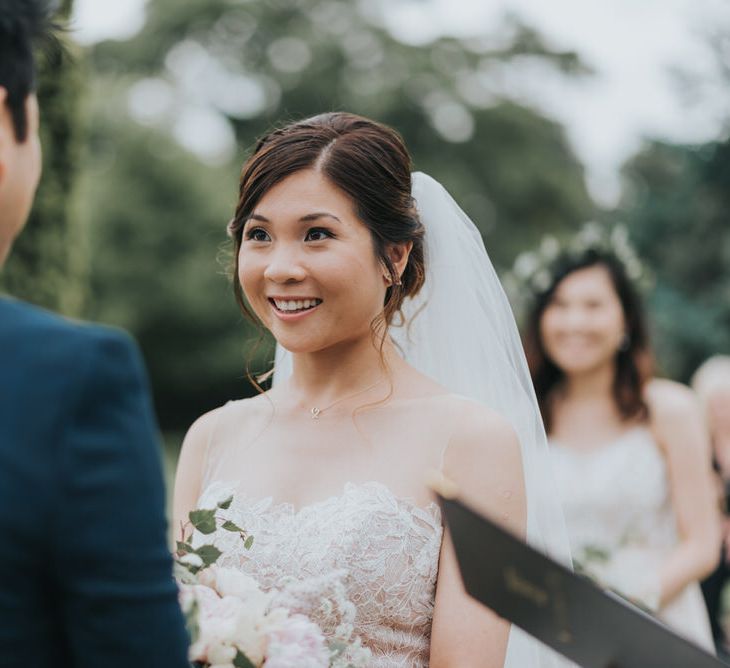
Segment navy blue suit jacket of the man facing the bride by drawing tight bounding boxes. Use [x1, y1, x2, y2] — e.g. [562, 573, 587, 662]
[0, 299, 189, 668]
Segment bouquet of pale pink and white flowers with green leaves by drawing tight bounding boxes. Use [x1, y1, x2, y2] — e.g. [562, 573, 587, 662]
[175, 496, 370, 668]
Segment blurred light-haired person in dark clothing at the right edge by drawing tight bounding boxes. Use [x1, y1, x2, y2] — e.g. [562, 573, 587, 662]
[692, 355, 730, 658]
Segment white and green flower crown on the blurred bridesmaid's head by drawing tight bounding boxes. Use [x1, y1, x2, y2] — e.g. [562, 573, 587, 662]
[504, 221, 651, 310]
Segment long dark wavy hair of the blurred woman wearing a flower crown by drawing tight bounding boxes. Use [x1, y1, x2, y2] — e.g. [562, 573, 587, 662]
[524, 248, 654, 432]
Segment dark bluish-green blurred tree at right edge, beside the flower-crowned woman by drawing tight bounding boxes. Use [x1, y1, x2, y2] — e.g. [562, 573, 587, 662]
[618, 140, 730, 381]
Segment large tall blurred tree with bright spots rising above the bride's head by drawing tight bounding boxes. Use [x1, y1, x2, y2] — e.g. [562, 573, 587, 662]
[89, 0, 593, 264]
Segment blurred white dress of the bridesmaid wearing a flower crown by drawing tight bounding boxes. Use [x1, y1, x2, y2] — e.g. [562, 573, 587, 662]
[550, 427, 714, 652]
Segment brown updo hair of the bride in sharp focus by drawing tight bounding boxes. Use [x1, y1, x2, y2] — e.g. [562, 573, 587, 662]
[228, 112, 425, 342]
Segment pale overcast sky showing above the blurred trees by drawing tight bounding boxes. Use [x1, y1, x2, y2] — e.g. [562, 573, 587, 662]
[69, 0, 730, 205]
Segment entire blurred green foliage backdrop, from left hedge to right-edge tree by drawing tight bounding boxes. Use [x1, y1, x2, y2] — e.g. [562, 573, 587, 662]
[3, 0, 730, 430]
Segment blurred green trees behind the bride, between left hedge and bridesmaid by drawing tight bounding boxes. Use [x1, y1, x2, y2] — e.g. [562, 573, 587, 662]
[79, 0, 594, 429]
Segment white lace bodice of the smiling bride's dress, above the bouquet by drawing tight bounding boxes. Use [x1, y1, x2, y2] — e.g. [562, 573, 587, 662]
[198, 481, 443, 668]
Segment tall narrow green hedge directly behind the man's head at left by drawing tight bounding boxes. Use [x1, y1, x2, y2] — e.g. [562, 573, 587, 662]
[0, 0, 88, 316]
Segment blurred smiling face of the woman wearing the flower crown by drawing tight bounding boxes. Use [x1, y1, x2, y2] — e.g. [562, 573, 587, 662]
[540, 265, 625, 375]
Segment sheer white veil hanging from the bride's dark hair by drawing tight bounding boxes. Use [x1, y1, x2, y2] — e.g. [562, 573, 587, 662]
[275, 172, 570, 668]
